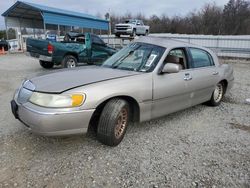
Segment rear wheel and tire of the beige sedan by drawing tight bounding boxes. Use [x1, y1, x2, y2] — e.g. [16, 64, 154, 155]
[208, 82, 225, 106]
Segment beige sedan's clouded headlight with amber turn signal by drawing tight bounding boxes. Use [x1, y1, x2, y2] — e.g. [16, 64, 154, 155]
[29, 92, 86, 108]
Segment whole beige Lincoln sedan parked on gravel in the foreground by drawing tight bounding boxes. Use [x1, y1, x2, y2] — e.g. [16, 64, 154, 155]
[11, 37, 234, 146]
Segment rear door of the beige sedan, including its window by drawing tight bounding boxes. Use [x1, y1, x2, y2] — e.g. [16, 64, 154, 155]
[187, 48, 219, 106]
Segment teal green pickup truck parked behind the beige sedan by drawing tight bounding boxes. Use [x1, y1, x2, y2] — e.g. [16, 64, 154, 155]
[26, 32, 117, 69]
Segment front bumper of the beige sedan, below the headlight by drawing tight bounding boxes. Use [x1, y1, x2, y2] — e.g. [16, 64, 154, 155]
[11, 100, 94, 136]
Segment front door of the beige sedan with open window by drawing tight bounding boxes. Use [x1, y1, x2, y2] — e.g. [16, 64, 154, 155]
[152, 49, 191, 118]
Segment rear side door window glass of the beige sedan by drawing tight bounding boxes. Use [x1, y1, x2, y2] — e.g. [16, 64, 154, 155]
[190, 48, 213, 68]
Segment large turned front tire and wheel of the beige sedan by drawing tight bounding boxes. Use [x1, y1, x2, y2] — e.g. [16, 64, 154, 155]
[97, 98, 130, 146]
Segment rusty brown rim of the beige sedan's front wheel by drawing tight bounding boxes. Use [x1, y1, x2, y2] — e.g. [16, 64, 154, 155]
[115, 108, 128, 139]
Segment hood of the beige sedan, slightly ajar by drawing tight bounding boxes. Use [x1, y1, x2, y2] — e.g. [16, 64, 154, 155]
[29, 66, 141, 93]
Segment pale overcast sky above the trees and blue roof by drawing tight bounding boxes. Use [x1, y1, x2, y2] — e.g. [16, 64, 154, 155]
[0, 0, 229, 29]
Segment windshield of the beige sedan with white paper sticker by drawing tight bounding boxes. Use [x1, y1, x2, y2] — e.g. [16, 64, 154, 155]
[102, 43, 165, 72]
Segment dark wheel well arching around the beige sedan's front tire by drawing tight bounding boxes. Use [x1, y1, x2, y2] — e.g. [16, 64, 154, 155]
[88, 96, 140, 131]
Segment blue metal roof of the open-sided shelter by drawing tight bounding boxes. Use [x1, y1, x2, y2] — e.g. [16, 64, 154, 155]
[2, 1, 108, 30]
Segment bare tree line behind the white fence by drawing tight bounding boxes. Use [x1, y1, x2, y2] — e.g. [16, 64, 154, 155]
[111, 0, 250, 35]
